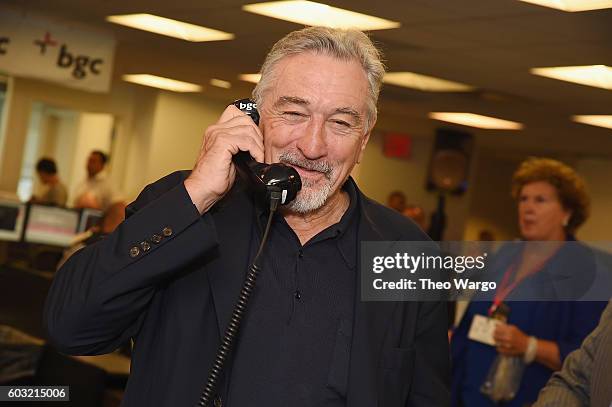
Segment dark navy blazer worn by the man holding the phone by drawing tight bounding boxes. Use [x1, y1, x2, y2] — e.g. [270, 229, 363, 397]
[44, 171, 450, 407]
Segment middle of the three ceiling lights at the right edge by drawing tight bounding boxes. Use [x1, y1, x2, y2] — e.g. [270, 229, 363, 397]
[530, 65, 612, 90]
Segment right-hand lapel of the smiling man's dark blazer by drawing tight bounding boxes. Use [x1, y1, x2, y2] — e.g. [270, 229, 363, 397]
[347, 200, 398, 407]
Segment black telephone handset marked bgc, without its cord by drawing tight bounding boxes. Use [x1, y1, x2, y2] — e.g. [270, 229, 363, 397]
[233, 99, 302, 205]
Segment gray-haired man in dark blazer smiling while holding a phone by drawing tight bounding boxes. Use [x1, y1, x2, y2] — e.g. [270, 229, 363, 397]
[45, 28, 449, 407]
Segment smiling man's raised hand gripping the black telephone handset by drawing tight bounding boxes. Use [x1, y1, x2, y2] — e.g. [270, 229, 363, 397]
[185, 105, 264, 213]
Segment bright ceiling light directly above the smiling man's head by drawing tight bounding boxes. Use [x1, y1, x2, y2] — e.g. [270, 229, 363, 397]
[242, 0, 401, 31]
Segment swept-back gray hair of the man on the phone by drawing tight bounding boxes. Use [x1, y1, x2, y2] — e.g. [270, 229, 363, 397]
[253, 27, 385, 131]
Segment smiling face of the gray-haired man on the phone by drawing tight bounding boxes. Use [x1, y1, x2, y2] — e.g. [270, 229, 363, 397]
[260, 53, 370, 213]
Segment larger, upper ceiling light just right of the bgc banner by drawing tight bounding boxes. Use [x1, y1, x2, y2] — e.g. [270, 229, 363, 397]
[106, 14, 234, 42]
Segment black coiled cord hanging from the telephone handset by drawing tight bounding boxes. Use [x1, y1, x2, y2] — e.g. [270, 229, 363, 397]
[197, 192, 281, 407]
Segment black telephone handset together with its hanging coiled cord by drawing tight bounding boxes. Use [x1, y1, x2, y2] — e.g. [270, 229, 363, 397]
[197, 99, 302, 407]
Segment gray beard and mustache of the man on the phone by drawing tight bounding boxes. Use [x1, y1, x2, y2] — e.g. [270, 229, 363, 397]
[278, 151, 336, 214]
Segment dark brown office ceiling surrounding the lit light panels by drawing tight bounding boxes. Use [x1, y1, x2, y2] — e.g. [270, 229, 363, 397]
[4, 0, 612, 158]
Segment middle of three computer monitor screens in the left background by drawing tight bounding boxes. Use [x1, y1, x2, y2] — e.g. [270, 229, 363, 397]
[24, 204, 79, 247]
